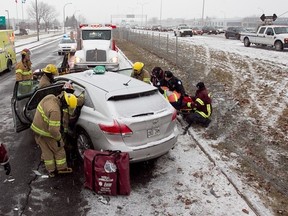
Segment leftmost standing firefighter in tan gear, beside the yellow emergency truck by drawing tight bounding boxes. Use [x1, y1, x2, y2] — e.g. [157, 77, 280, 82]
[16, 49, 33, 81]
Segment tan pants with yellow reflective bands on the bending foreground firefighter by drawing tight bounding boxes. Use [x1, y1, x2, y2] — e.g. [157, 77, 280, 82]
[35, 134, 67, 172]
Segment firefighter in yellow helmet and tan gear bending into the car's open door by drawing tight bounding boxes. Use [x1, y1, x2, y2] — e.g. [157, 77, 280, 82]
[31, 91, 77, 177]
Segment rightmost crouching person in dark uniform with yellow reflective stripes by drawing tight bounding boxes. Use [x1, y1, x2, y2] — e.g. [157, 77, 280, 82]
[186, 82, 212, 127]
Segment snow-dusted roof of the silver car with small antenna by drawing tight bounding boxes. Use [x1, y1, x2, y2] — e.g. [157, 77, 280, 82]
[60, 70, 157, 98]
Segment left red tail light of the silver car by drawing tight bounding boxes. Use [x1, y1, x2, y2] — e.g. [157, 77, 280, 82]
[99, 120, 133, 135]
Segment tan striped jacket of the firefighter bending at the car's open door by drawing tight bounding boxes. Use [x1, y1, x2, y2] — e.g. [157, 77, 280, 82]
[31, 95, 61, 141]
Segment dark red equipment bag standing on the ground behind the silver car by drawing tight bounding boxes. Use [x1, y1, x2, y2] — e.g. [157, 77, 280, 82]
[84, 149, 131, 195]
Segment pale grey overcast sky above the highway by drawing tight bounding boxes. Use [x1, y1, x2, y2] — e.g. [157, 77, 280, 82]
[0, 0, 288, 23]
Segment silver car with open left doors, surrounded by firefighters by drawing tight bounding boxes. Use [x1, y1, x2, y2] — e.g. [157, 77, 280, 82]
[11, 68, 178, 162]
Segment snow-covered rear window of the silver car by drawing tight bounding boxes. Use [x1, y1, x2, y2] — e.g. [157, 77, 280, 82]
[108, 89, 169, 117]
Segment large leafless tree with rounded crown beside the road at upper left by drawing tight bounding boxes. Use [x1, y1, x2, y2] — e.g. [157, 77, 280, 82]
[27, 1, 58, 31]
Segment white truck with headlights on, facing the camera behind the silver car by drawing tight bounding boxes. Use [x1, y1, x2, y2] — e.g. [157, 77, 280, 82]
[74, 24, 119, 71]
